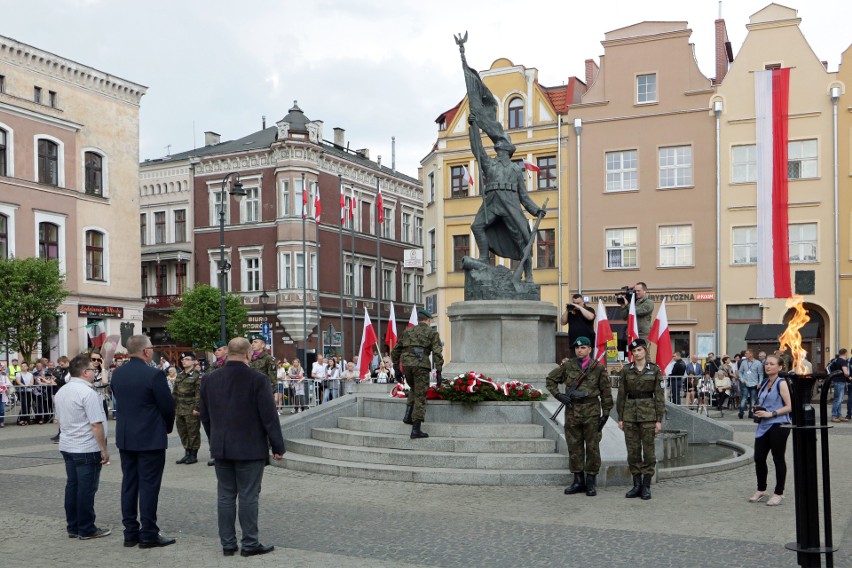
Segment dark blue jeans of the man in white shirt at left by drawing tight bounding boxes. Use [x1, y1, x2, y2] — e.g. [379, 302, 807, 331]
[62, 452, 101, 536]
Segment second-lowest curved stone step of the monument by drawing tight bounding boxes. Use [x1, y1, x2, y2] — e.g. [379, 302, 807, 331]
[287, 439, 568, 470]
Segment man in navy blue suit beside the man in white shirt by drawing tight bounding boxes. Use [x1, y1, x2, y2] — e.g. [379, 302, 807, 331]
[110, 335, 175, 548]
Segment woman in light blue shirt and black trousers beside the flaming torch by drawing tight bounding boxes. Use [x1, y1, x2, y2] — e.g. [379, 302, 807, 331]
[749, 355, 793, 507]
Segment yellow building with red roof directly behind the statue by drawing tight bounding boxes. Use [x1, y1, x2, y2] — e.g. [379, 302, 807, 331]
[421, 59, 585, 360]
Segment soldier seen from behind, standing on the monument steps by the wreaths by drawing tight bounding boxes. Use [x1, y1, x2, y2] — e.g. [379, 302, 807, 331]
[391, 308, 444, 440]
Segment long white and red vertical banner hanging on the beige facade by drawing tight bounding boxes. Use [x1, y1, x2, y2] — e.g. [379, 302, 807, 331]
[754, 68, 792, 298]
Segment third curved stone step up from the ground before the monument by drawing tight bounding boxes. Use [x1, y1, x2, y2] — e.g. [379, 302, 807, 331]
[311, 428, 556, 454]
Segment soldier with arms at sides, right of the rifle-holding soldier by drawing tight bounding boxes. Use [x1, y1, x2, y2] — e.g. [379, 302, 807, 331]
[616, 339, 666, 500]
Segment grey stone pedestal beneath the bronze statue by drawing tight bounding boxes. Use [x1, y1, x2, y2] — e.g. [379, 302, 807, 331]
[443, 300, 559, 388]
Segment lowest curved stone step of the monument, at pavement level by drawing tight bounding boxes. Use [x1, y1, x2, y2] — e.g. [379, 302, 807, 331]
[280, 451, 572, 486]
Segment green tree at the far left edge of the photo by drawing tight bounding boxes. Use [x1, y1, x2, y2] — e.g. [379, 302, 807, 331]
[0, 257, 68, 363]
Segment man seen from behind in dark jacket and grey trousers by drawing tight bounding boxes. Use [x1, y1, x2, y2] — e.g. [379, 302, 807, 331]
[201, 337, 284, 556]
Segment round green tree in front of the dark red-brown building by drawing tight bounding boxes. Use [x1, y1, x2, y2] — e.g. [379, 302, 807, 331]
[166, 284, 248, 349]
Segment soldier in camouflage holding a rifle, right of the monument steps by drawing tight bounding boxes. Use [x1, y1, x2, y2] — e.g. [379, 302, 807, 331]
[547, 337, 612, 497]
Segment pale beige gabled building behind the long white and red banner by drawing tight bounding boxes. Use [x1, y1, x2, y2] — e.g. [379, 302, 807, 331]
[710, 4, 849, 369]
